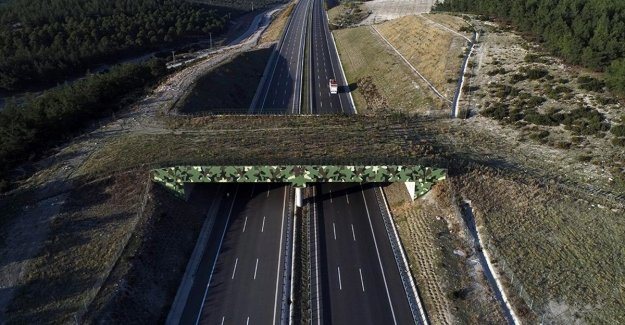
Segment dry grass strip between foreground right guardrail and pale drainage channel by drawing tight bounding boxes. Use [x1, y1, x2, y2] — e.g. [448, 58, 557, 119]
[384, 182, 504, 324]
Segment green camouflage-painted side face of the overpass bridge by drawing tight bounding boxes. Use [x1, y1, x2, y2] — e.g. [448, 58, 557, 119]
[150, 165, 446, 199]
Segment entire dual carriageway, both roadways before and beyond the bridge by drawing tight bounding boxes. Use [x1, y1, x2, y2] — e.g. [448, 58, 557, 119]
[175, 0, 422, 325]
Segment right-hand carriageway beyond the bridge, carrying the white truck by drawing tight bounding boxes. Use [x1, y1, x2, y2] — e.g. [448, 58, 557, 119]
[308, 0, 355, 114]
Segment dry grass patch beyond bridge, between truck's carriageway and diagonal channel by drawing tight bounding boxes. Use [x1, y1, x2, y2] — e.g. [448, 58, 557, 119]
[333, 26, 434, 114]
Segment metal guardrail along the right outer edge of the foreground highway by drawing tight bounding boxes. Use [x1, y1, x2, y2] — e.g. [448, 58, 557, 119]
[374, 188, 428, 325]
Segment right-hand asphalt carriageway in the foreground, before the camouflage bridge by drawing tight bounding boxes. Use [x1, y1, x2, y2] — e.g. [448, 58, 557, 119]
[311, 183, 415, 325]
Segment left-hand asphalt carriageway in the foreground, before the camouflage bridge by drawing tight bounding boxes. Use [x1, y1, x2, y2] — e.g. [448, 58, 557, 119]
[180, 184, 293, 324]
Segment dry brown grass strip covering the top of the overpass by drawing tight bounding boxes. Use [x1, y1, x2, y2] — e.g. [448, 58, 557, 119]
[77, 116, 442, 175]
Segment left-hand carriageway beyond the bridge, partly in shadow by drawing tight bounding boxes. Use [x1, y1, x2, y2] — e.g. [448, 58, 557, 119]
[252, 0, 311, 114]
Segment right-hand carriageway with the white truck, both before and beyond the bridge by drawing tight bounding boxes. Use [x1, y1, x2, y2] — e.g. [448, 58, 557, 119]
[308, 0, 416, 324]
